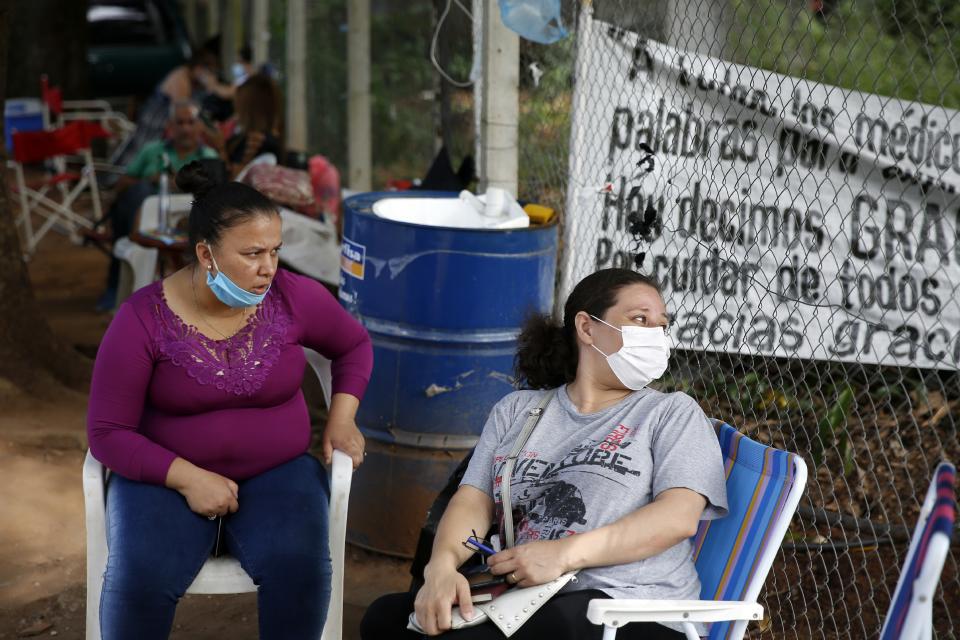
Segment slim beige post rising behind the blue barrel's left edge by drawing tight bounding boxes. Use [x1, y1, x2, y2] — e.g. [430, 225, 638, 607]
[347, 0, 373, 191]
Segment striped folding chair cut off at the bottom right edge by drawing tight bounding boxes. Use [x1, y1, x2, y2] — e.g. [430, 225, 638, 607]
[880, 462, 957, 640]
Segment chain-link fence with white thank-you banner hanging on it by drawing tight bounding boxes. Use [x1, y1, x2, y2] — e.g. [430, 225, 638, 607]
[519, 0, 960, 638]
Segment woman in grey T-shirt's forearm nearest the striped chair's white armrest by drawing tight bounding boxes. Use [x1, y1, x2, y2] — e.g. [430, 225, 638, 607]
[562, 489, 706, 571]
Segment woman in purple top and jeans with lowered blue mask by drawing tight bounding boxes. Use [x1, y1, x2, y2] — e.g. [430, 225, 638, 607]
[87, 163, 373, 640]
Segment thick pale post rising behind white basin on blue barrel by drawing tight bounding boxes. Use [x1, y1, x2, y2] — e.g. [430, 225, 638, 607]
[480, 0, 520, 197]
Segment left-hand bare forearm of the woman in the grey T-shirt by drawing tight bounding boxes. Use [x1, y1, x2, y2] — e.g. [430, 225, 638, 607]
[424, 485, 493, 573]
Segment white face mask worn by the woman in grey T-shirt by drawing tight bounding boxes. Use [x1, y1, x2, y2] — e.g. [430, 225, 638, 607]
[590, 316, 670, 391]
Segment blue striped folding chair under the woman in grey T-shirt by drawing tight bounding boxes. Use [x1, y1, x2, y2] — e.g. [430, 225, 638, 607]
[587, 421, 807, 640]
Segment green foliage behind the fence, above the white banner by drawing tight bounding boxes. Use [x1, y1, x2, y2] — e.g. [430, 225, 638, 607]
[730, 0, 960, 109]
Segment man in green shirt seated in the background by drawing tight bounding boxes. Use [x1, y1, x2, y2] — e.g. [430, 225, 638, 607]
[97, 99, 217, 311]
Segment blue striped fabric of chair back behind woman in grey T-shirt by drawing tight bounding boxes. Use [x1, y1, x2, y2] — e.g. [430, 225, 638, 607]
[693, 422, 798, 640]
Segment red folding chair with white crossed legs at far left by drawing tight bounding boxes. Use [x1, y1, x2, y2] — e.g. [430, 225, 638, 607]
[8, 121, 109, 256]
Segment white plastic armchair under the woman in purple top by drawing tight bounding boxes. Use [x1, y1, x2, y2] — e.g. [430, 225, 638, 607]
[83, 348, 353, 640]
